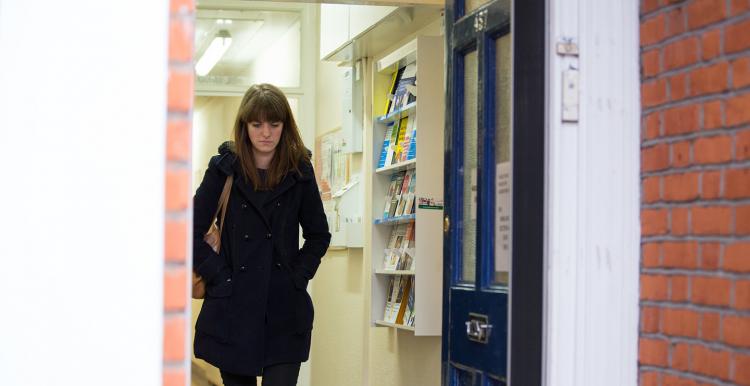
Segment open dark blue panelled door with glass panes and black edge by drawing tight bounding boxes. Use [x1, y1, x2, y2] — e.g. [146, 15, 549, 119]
[442, 0, 545, 386]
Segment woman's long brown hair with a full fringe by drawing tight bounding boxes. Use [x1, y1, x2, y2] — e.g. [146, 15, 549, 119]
[234, 83, 310, 190]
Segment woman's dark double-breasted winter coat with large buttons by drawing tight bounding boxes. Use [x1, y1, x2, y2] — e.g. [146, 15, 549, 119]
[193, 143, 331, 375]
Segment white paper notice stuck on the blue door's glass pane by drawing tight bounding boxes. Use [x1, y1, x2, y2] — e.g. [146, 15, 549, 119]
[495, 162, 513, 272]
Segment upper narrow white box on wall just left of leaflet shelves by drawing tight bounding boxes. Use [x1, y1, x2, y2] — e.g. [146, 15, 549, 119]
[341, 61, 364, 153]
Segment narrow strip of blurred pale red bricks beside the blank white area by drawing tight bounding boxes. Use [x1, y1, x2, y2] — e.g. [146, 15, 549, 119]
[163, 0, 195, 386]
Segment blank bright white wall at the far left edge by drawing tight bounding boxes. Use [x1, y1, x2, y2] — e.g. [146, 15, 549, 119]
[0, 0, 169, 386]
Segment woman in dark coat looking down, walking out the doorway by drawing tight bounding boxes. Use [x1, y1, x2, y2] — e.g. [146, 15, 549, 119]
[193, 84, 331, 386]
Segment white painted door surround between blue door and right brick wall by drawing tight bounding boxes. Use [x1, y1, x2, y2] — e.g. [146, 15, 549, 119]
[545, 0, 640, 386]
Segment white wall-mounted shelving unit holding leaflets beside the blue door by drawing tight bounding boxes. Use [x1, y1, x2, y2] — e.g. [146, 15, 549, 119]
[369, 36, 445, 336]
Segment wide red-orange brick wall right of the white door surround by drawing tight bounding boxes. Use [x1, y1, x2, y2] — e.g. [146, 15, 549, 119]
[639, 0, 750, 386]
